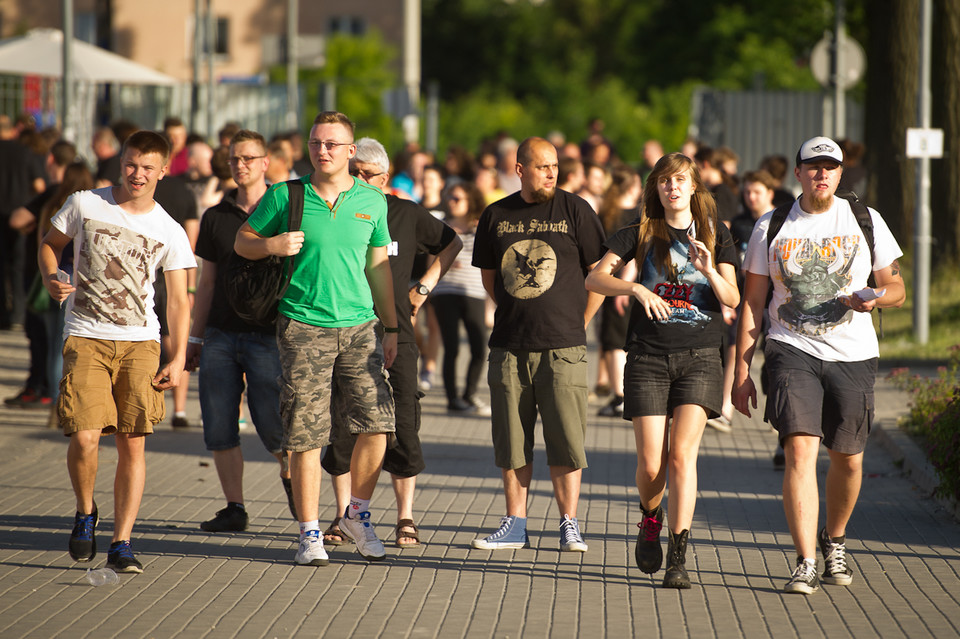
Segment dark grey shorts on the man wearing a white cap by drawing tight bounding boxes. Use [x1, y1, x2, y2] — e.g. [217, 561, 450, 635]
[764, 339, 877, 455]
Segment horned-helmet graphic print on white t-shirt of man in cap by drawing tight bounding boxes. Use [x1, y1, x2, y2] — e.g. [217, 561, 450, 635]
[771, 235, 860, 335]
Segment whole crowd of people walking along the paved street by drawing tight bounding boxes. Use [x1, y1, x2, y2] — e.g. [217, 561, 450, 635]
[0, 112, 904, 594]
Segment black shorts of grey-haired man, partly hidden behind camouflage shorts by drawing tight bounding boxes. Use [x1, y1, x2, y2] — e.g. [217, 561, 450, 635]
[320, 342, 426, 477]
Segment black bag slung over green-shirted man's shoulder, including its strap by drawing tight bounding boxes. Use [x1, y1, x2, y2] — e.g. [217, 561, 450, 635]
[226, 180, 304, 326]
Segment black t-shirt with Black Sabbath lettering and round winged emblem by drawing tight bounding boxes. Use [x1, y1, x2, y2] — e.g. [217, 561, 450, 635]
[473, 189, 604, 351]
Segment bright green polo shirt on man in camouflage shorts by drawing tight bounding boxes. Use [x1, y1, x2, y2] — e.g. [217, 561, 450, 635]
[247, 175, 390, 328]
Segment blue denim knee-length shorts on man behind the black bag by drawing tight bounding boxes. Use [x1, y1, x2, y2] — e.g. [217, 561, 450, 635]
[200, 327, 283, 454]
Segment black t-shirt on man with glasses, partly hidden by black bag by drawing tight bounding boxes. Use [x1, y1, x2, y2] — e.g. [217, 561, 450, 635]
[196, 189, 275, 334]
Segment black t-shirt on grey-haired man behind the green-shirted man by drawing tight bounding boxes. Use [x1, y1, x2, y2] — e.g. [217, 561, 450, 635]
[387, 194, 457, 343]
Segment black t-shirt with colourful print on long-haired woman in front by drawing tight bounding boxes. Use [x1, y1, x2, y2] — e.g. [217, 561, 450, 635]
[605, 218, 738, 355]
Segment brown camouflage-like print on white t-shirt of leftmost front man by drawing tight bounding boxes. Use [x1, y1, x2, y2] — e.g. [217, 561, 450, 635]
[73, 220, 163, 326]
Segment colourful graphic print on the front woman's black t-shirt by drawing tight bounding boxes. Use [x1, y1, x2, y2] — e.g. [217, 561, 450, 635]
[640, 241, 711, 326]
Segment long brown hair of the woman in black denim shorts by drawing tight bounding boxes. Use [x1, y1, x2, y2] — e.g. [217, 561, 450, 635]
[637, 153, 717, 270]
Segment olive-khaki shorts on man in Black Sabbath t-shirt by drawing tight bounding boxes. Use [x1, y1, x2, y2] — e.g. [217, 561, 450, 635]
[487, 346, 587, 469]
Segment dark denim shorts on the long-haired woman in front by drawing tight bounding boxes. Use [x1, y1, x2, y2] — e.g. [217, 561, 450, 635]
[623, 347, 723, 419]
